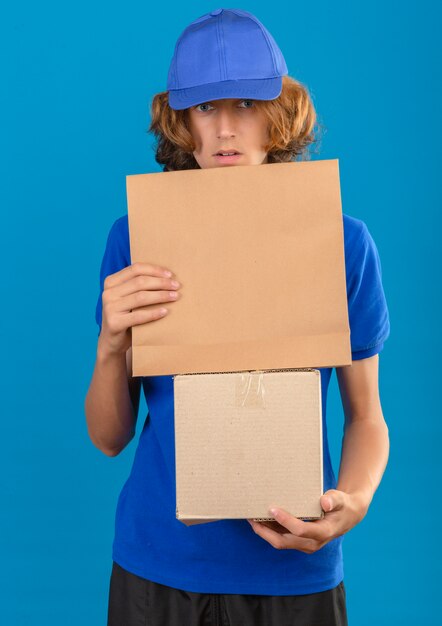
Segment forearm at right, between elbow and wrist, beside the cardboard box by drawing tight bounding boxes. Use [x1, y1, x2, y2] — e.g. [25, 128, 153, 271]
[336, 409, 390, 509]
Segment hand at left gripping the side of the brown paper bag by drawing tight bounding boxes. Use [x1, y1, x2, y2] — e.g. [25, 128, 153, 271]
[98, 263, 181, 354]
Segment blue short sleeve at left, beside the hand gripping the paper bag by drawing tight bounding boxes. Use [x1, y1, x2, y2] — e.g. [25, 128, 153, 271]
[95, 215, 131, 335]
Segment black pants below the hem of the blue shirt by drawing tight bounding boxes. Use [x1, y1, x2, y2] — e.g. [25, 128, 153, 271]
[107, 562, 347, 626]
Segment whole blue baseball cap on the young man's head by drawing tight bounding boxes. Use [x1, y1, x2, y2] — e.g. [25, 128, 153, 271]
[167, 9, 288, 110]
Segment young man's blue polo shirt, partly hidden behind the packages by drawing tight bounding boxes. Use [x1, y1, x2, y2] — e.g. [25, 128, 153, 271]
[96, 208, 390, 595]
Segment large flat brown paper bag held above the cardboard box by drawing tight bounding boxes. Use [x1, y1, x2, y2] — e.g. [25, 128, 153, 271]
[127, 159, 351, 376]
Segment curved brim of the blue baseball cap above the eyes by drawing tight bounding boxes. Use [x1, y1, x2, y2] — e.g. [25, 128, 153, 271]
[169, 76, 282, 110]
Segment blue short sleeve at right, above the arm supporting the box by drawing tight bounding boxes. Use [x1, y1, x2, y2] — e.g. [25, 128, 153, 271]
[346, 220, 390, 360]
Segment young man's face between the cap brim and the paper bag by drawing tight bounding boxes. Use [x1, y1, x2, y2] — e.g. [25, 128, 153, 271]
[188, 98, 269, 169]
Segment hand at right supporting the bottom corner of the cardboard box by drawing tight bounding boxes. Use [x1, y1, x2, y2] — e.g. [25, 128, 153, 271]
[247, 489, 368, 554]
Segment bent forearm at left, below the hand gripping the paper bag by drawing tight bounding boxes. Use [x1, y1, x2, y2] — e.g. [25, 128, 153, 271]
[85, 341, 136, 456]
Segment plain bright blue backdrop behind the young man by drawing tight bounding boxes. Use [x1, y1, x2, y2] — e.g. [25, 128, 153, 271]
[0, 0, 442, 626]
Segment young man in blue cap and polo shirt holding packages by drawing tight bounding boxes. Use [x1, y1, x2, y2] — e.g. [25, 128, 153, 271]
[85, 9, 389, 626]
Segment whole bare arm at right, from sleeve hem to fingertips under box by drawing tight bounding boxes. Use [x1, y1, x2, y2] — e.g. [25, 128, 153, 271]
[247, 354, 389, 554]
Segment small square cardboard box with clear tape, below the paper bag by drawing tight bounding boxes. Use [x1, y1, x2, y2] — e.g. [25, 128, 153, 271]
[174, 368, 323, 525]
